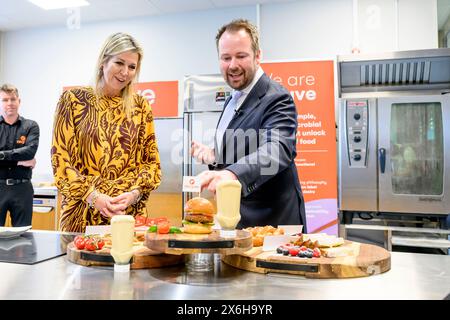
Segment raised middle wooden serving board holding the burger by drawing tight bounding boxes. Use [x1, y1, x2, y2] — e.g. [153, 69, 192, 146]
[145, 230, 253, 255]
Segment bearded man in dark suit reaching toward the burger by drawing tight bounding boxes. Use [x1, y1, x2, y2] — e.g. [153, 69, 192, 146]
[191, 20, 306, 232]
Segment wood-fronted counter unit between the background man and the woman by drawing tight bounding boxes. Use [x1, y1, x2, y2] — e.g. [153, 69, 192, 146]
[32, 185, 59, 230]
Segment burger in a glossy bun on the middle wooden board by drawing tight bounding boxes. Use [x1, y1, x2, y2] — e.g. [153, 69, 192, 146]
[183, 197, 215, 234]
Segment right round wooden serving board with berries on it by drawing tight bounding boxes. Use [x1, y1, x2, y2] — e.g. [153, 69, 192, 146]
[222, 241, 391, 279]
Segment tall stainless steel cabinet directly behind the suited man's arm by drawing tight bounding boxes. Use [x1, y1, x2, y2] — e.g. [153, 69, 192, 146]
[183, 74, 232, 204]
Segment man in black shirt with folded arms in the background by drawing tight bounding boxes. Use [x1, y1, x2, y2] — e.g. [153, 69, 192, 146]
[0, 84, 39, 227]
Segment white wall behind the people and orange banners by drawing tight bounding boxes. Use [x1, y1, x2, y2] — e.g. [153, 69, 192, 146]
[0, 0, 438, 182]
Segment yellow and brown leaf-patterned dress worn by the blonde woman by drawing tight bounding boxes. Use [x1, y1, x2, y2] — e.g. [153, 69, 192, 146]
[51, 87, 161, 232]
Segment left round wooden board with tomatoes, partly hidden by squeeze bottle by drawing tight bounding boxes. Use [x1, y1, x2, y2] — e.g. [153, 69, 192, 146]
[67, 242, 184, 269]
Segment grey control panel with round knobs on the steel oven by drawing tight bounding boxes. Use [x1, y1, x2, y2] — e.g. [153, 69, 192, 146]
[346, 100, 369, 168]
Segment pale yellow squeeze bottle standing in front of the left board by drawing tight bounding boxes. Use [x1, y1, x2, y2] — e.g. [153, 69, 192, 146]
[111, 215, 134, 272]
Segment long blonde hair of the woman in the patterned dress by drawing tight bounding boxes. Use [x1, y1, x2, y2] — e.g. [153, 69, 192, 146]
[94, 32, 144, 117]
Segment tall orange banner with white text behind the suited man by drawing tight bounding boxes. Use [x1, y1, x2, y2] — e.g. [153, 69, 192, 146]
[261, 61, 337, 234]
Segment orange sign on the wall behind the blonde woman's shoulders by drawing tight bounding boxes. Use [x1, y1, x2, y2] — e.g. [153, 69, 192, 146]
[63, 81, 178, 118]
